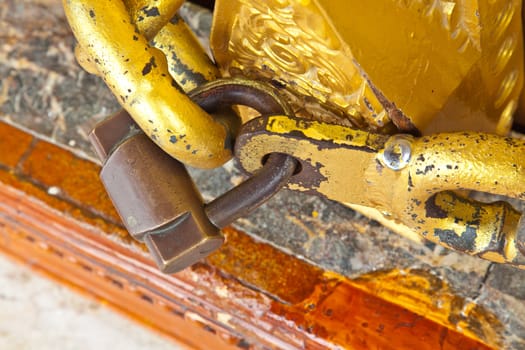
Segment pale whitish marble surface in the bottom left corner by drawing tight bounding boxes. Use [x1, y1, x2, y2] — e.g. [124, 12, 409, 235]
[0, 255, 181, 350]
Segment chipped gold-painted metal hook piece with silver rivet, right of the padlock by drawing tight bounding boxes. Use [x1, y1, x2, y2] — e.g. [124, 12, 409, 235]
[236, 116, 525, 268]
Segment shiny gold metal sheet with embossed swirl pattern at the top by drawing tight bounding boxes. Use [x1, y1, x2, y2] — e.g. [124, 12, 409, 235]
[211, 0, 523, 134]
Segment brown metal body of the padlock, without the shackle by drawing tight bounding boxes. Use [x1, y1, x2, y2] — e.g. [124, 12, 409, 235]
[91, 111, 224, 273]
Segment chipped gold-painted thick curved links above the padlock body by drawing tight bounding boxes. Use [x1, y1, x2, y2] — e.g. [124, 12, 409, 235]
[63, 0, 232, 168]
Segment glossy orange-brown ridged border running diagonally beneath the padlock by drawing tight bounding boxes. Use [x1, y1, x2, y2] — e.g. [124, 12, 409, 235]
[0, 119, 489, 349]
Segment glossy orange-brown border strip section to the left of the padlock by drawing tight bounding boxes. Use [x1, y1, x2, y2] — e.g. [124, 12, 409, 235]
[0, 122, 130, 245]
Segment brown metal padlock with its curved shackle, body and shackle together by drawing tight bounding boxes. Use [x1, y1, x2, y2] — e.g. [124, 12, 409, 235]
[90, 79, 298, 273]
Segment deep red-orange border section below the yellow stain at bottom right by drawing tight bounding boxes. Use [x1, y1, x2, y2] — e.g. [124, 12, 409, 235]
[272, 279, 490, 350]
